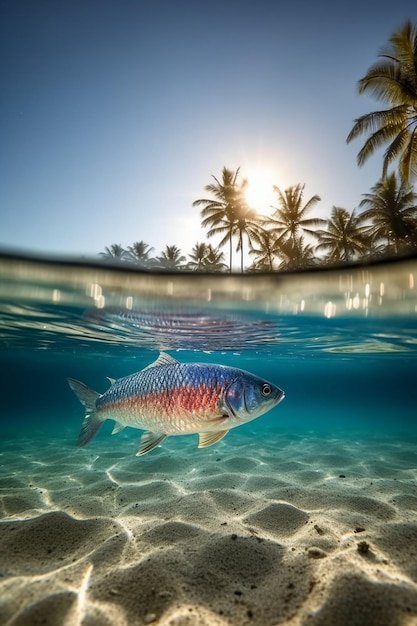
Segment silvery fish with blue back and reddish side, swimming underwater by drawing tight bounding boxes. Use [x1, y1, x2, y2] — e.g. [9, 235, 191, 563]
[68, 352, 285, 456]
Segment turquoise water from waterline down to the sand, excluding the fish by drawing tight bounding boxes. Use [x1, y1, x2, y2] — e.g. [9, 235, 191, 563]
[0, 250, 417, 438]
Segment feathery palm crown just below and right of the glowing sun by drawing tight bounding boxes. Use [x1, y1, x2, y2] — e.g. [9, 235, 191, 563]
[268, 184, 326, 249]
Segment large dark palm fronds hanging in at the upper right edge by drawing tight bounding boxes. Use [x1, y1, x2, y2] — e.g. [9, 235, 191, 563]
[346, 20, 417, 184]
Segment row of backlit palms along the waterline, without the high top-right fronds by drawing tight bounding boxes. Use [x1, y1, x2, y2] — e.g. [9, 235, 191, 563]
[101, 168, 417, 272]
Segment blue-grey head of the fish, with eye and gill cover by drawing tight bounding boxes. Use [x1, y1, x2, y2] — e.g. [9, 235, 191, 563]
[223, 371, 285, 422]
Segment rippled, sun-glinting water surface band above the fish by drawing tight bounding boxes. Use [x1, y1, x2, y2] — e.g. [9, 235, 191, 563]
[0, 250, 417, 354]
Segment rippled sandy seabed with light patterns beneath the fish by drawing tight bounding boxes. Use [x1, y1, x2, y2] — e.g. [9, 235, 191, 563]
[0, 429, 417, 626]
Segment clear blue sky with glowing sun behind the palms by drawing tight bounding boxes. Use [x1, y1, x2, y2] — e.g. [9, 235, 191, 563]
[0, 0, 417, 264]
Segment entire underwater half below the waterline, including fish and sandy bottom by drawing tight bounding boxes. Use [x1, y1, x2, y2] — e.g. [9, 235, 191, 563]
[0, 254, 417, 626]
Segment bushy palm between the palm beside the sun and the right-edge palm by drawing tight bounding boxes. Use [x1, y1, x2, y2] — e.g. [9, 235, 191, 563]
[316, 206, 369, 262]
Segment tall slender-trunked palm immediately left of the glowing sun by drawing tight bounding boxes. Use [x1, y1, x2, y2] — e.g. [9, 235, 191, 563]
[193, 167, 242, 272]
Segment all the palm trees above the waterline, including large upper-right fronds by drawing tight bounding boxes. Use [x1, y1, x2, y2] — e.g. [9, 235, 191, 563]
[102, 20, 417, 272]
